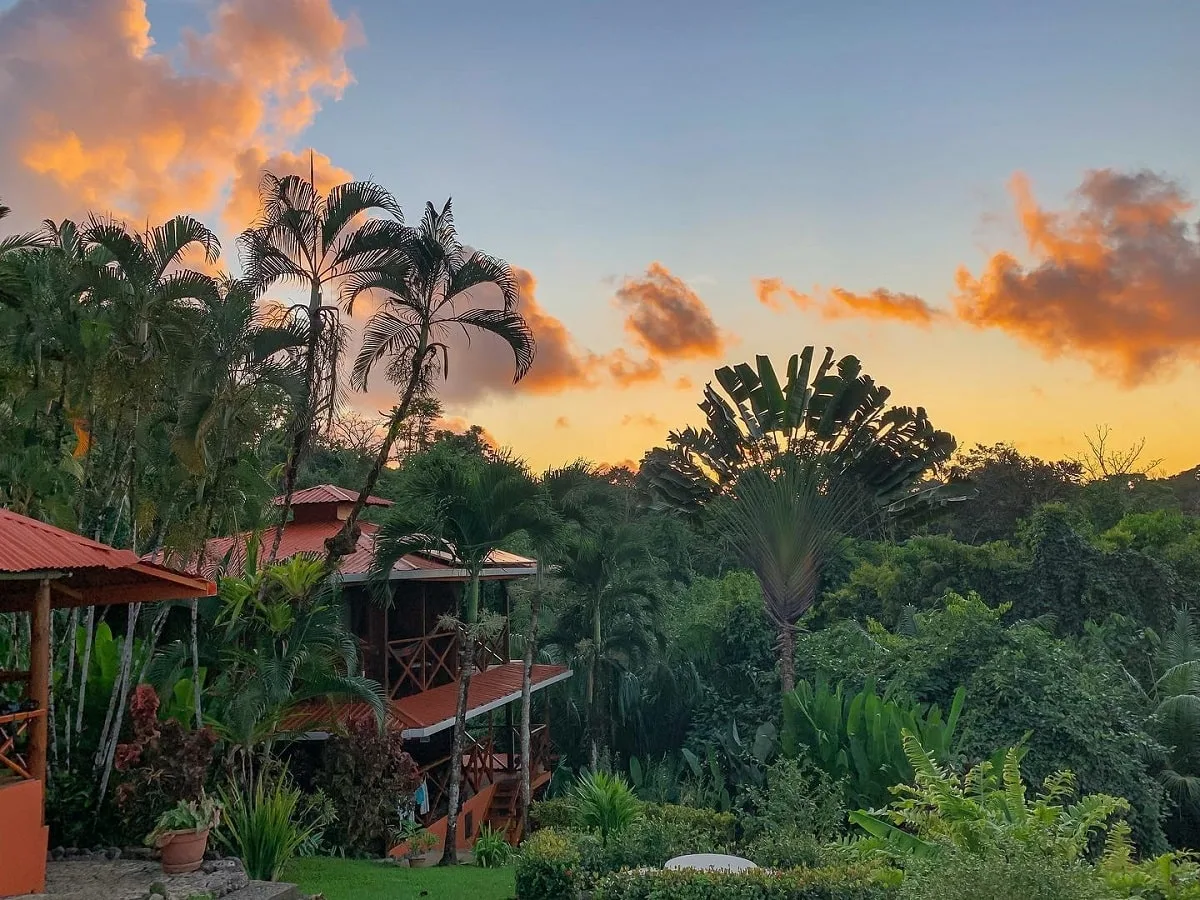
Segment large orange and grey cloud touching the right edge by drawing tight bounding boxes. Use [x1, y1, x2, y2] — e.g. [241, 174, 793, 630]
[954, 169, 1200, 385]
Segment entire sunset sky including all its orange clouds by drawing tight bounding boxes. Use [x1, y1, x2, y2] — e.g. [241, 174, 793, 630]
[0, 0, 1200, 472]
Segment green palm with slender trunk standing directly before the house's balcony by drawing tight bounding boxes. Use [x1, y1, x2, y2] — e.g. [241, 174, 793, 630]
[374, 448, 556, 865]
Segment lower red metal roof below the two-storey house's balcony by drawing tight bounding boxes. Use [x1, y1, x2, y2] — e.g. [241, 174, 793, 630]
[281, 661, 571, 737]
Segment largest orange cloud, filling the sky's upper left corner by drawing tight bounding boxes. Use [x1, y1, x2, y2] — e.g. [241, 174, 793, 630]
[0, 0, 358, 229]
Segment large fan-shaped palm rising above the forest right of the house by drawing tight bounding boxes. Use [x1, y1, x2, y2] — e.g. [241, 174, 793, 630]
[642, 347, 955, 691]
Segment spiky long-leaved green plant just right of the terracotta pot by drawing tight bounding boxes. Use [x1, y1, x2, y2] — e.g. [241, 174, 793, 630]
[216, 772, 328, 881]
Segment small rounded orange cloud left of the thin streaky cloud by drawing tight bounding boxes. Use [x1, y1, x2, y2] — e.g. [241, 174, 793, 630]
[617, 263, 727, 359]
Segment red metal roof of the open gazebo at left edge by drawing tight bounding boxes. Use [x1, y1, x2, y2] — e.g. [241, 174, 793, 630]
[0, 509, 216, 612]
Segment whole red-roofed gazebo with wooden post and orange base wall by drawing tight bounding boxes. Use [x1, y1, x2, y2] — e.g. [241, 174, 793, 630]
[0, 509, 216, 898]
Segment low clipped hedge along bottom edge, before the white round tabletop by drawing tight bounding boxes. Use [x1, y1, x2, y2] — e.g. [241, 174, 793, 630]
[592, 866, 897, 900]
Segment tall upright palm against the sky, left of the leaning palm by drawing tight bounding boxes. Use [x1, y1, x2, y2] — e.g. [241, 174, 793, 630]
[239, 173, 406, 560]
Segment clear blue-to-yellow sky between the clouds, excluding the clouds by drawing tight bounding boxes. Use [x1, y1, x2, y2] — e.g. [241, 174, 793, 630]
[9, 0, 1200, 468]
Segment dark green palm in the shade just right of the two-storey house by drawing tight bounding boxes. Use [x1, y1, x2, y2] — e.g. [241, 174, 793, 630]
[554, 521, 662, 769]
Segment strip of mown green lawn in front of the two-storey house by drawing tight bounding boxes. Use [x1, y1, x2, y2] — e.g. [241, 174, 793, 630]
[283, 857, 516, 900]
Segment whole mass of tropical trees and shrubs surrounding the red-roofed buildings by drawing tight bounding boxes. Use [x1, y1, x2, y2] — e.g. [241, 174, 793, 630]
[7, 175, 1200, 900]
